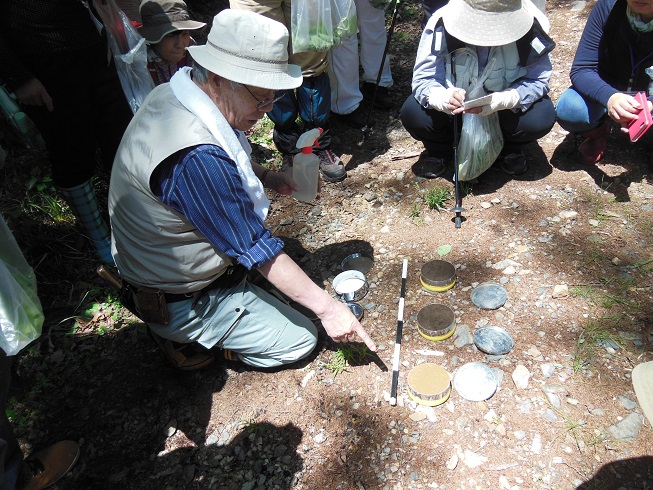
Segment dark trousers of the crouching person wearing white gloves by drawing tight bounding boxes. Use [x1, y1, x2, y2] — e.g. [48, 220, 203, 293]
[400, 95, 555, 156]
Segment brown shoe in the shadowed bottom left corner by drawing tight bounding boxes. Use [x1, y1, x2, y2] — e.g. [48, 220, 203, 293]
[24, 441, 79, 490]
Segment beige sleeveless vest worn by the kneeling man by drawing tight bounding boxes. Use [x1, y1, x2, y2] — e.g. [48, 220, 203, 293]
[109, 83, 233, 293]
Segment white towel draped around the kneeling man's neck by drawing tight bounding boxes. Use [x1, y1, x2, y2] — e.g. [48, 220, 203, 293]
[170, 66, 270, 221]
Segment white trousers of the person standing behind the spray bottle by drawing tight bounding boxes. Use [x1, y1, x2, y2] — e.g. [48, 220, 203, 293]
[328, 0, 393, 114]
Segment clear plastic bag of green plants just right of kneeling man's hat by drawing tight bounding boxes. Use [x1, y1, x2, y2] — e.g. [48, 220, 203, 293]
[290, 0, 358, 53]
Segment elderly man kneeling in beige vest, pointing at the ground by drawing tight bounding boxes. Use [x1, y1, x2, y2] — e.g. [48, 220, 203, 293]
[109, 9, 376, 368]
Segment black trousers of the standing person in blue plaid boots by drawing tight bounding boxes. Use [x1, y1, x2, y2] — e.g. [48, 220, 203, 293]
[23, 42, 132, 187]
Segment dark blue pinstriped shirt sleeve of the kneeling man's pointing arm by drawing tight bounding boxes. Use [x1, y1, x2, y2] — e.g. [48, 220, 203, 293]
[150, 145, 284, 269]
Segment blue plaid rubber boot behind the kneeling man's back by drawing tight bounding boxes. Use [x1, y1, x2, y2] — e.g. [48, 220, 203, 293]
[59, 180, 114, 265]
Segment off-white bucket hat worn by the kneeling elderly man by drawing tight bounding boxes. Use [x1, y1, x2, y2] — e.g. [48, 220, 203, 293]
[188, 9, 303, 90]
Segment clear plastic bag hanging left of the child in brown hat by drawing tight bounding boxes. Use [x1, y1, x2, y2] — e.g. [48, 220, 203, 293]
[93, 0, 154, 113]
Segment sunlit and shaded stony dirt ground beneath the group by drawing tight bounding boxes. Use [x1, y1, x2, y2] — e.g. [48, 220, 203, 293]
[0, 1, 653, 490]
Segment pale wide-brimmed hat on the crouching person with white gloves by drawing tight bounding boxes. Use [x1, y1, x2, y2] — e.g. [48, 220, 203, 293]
[442, 0, 534, 46]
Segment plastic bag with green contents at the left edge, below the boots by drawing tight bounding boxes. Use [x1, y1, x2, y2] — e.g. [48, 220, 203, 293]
[0, 215, 43, 356]
